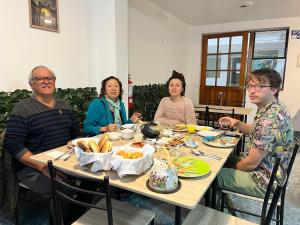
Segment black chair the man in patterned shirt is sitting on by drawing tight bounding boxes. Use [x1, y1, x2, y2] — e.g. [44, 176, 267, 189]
[221, 142, 299, 225]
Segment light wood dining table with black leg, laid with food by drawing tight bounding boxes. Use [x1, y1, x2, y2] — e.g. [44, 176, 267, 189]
[31, 129, 239, 225]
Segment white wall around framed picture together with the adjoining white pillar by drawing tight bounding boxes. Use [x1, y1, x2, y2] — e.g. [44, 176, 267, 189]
[0, 0, 128, 103]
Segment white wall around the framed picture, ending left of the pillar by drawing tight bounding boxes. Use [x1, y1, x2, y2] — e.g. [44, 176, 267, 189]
[0, 0, 88, 91]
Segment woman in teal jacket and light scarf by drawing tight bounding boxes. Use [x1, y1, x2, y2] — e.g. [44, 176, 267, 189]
[83, 76, 140, 135]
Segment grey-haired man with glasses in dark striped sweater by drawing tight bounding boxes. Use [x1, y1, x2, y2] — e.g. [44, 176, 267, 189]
[4, 66, 80, 216]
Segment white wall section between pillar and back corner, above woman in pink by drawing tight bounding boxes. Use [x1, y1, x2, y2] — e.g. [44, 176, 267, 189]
[128, 0, 189, 88]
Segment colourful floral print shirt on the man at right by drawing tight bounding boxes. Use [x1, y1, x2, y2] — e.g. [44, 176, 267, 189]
[249, 99, 294, 188]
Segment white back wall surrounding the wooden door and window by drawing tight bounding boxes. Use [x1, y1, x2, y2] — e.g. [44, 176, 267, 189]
[188, 17, 300, 121]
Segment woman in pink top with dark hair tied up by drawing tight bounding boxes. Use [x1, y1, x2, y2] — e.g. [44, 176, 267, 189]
[154, 71, 196, 125]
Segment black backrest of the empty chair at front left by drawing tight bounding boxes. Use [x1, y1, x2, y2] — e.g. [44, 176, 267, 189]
[48, 160, 113, 225]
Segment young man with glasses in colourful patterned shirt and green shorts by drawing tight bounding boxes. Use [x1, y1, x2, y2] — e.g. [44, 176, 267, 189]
[217, 69, 293, 197]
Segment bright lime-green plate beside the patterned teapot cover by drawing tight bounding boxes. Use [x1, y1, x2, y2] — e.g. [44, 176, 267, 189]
[173, 156, 210, 177]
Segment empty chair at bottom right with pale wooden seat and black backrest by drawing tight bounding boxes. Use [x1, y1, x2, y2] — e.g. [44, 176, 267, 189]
[183, 158, 287, 225]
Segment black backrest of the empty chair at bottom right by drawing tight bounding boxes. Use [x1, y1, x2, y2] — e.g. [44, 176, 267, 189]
[260, 158, 287, 225]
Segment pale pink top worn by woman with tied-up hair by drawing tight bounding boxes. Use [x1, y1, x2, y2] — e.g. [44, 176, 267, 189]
[154, 96, 196, 125]
